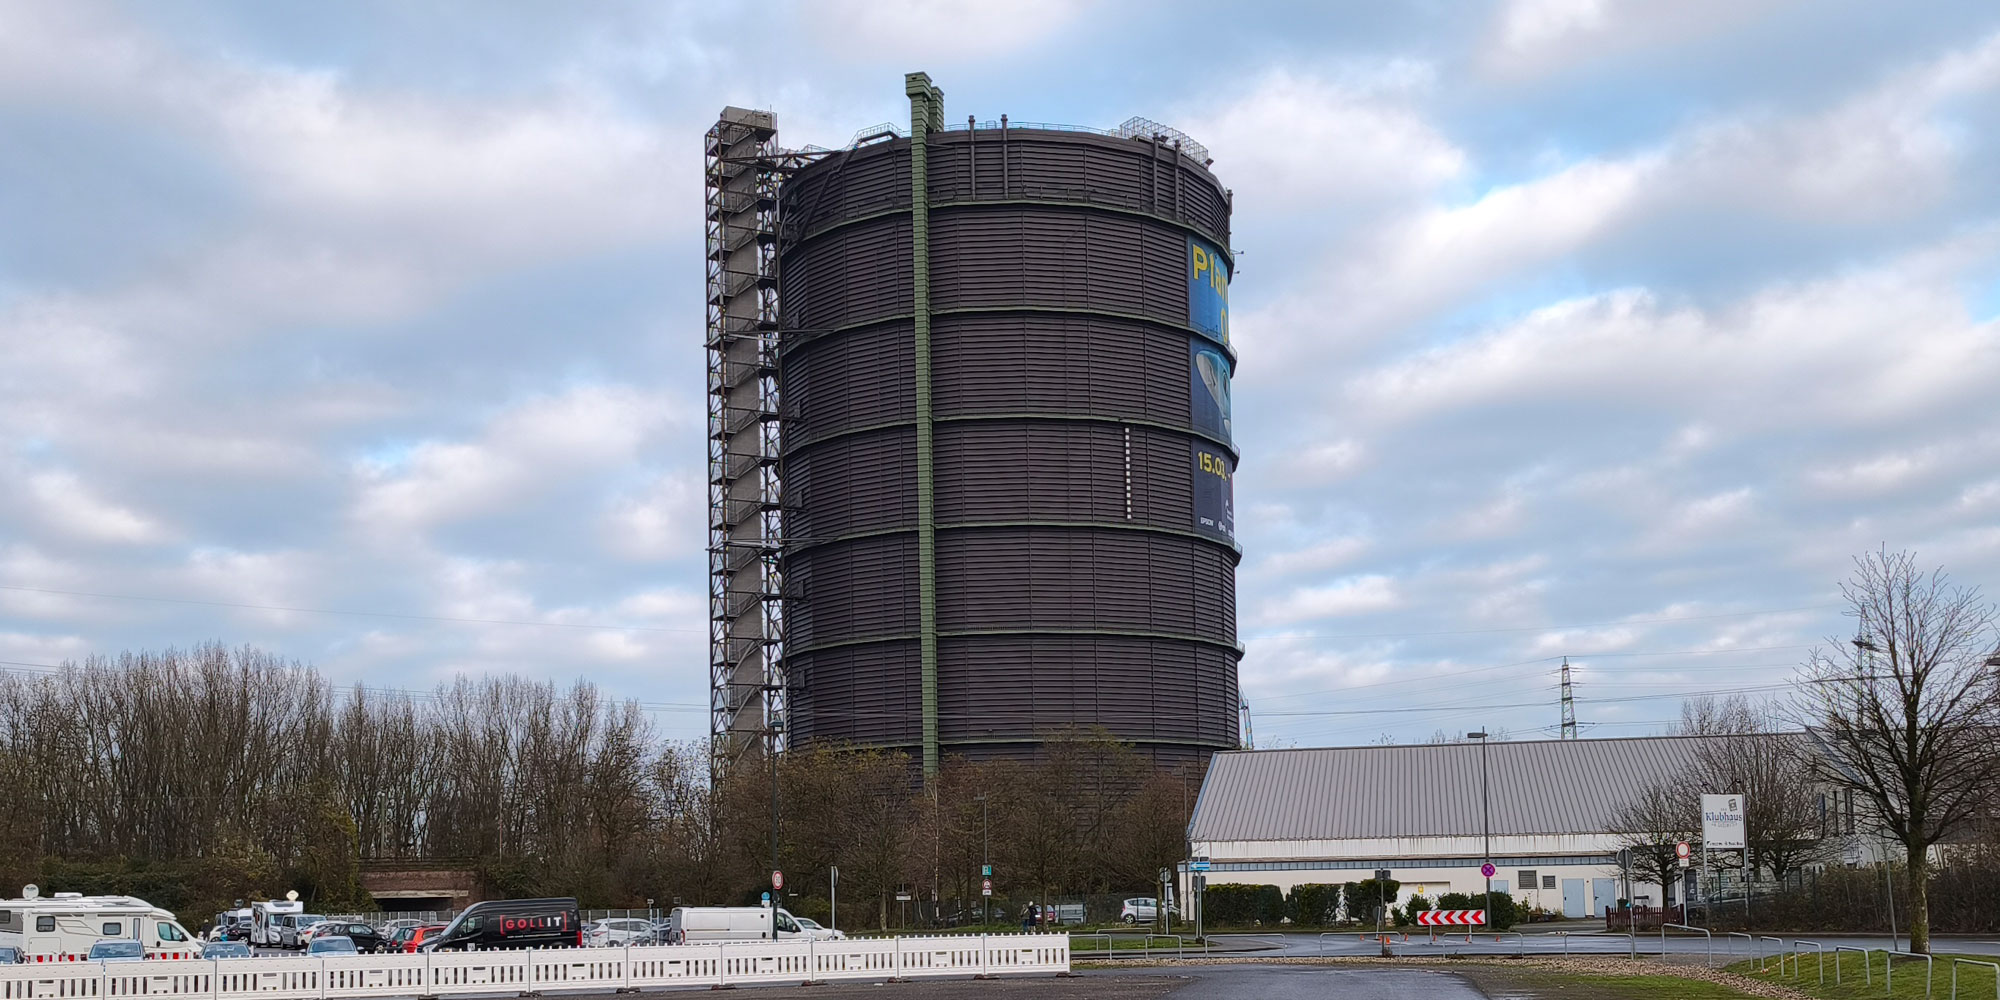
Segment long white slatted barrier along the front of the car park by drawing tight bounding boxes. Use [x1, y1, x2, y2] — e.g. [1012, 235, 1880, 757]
[0, 934, 1070, 1000]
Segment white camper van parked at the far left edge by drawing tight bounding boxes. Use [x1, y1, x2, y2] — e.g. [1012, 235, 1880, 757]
[0, 886, 202, 962]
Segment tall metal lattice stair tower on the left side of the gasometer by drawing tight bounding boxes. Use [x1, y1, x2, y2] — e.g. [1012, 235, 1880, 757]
[704, 108, 786, 776]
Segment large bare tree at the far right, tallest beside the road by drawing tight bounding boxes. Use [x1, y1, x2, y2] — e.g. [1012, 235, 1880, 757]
[1798, 548, 2000, 952]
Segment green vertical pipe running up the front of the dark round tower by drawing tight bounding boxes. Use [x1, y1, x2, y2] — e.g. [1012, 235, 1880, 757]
[904, 72, 944, 782]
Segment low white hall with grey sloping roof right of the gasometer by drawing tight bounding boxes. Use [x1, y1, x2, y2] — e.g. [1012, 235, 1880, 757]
[1180, 734, 1804, 918]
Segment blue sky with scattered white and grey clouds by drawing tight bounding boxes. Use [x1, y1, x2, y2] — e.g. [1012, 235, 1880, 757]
[0, 0, 2000, 746]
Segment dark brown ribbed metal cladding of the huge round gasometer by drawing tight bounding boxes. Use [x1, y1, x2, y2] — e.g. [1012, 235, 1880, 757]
[780, 128, 1242, 764]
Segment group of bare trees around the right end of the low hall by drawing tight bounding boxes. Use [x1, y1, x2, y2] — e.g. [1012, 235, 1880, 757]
[1614, 548, 2000, 952]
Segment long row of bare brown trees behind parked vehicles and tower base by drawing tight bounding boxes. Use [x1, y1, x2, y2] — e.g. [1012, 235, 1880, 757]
[0, 644, 1200, 922]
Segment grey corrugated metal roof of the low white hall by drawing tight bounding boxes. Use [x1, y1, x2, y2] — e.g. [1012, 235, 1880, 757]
[1188, 736, 1800, 842]
